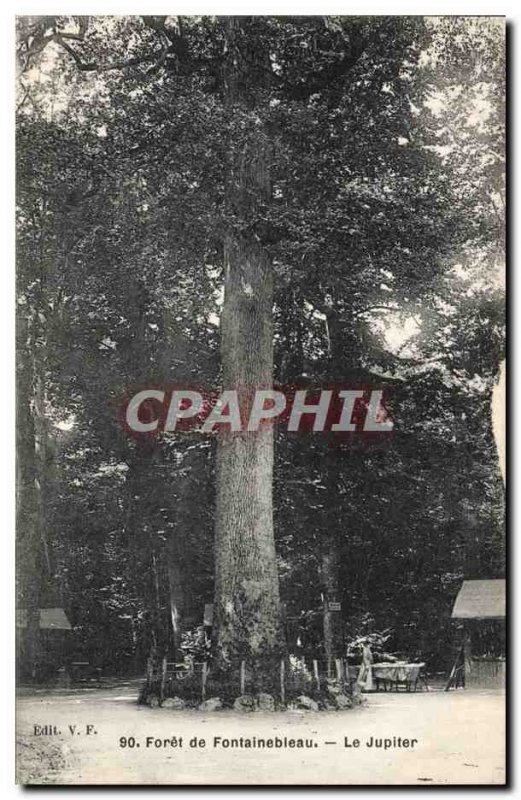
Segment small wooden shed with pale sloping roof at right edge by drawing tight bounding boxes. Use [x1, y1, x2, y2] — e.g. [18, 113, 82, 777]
[452, 579, 506, 687]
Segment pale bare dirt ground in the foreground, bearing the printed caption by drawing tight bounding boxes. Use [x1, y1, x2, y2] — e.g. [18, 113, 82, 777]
[17, 684, 505, 786]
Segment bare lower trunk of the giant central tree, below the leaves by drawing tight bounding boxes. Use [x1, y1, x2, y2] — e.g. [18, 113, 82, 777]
[215, 234, 281, 656]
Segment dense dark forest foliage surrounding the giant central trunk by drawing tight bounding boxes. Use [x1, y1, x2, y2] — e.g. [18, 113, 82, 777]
[18, 17, 504, 671]
